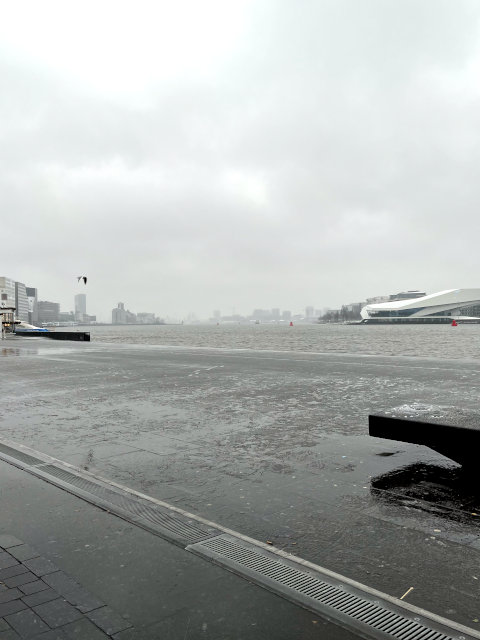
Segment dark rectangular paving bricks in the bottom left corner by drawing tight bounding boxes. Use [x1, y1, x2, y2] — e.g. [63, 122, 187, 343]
[0, 535, 134, 640]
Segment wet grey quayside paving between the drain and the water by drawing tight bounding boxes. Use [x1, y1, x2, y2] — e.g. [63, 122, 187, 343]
[0, 337, 480, 627]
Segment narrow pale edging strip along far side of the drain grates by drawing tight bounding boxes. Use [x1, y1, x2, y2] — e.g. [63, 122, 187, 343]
[0, 439, 480, 639]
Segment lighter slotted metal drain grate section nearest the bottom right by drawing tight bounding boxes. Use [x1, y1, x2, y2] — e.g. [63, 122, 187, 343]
[187, 535, 458, 640]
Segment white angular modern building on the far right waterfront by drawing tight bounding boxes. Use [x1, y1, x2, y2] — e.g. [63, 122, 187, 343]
[360, 289, 480, 324]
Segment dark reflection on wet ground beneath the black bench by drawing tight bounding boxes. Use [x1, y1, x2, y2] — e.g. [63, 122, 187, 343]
[371, 463, 480, 528]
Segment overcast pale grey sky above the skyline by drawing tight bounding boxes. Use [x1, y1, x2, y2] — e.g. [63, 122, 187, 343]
[0, 0, 480, 321]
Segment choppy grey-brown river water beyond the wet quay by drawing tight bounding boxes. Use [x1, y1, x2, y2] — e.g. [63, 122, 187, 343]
[88, 324, 480, 359]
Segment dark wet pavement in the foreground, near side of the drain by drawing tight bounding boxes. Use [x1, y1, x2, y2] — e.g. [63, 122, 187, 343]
[0, 462, 356, 640]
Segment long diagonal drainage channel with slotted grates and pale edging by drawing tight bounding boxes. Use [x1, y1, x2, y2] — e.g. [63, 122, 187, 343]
[0, 441, 480, 640]
